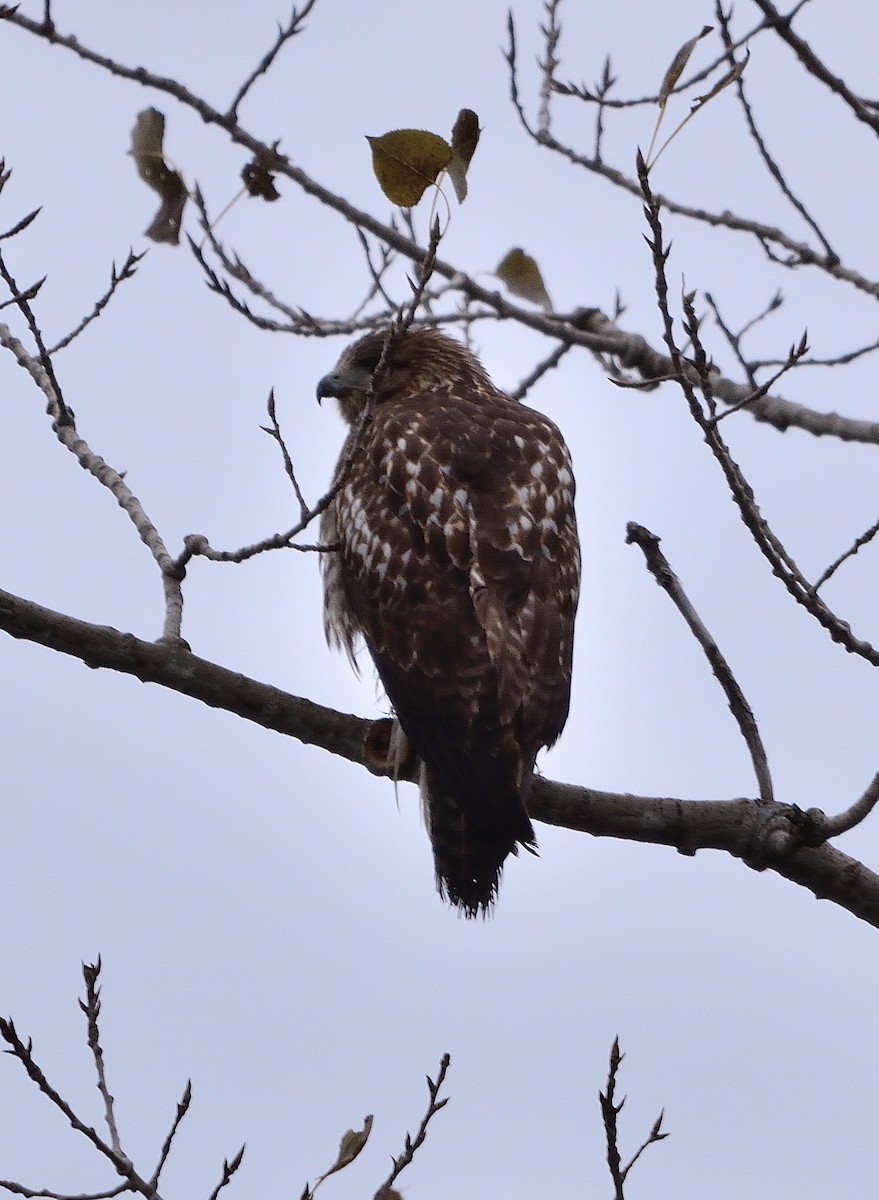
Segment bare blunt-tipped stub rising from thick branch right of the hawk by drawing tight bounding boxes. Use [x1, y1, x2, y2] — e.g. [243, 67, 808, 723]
[626, 521, 773, 804]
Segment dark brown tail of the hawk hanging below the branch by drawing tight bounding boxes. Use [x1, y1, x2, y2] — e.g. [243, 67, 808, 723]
[420, 767, 537, 917]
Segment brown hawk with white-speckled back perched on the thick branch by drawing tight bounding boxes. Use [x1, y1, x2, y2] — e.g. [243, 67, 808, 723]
[317, 328, 580, 917]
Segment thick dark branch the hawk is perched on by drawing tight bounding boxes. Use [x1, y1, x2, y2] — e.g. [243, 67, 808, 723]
[0, 592, 879, 928]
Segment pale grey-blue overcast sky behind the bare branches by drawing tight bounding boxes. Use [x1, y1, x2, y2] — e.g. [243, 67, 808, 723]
[0, 0, 879, 1200]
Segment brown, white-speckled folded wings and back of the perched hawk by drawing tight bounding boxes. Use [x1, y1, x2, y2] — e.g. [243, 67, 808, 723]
[328, 379, 579, 857]
